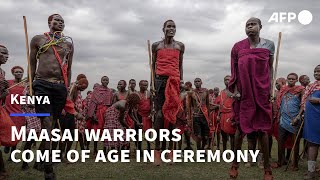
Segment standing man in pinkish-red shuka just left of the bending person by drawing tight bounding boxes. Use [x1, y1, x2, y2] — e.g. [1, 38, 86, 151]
[87, 76, 113, 155]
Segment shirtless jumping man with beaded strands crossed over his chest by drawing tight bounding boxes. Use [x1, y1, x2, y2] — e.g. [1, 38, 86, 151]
[30, 14, 73, 179]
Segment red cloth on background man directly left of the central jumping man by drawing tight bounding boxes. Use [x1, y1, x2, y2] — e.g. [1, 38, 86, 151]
[138, 92, 152, 131]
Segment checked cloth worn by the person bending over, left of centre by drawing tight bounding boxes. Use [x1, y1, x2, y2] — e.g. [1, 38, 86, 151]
[104, 106, 128, 148]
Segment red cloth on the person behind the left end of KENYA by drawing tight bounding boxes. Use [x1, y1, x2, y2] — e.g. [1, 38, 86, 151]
[5, 80, 26, 130]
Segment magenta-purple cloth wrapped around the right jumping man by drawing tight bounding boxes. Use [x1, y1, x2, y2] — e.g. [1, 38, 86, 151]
[229, 39, 272, 134]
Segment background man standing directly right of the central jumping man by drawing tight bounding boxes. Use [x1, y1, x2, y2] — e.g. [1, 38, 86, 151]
[175, 81, 192, 150]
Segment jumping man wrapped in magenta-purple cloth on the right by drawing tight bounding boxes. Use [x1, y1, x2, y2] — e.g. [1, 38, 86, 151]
[229, 18, 275, 179]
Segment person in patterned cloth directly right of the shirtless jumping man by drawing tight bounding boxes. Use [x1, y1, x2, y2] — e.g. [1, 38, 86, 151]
[70, 78, 89, 150]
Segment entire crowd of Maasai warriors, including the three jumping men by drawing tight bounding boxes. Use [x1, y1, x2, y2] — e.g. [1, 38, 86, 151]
[0, 14, 320, 180]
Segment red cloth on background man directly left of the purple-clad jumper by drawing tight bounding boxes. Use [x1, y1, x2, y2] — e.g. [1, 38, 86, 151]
[220, 90, 236, 134]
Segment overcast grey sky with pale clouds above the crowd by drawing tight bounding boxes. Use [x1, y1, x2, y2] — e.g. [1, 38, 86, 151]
[0, 0, 320, 92]
